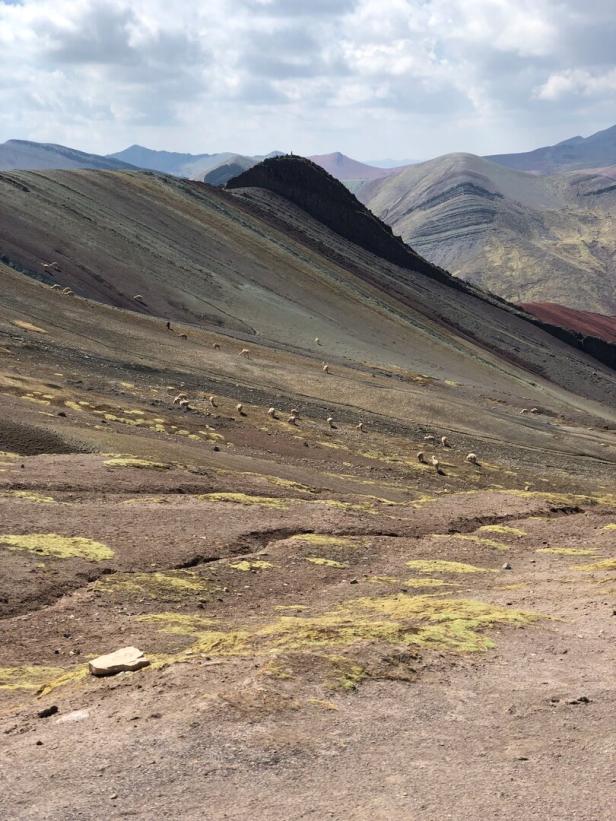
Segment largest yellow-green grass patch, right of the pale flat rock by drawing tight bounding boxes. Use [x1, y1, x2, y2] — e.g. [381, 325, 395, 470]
[139, 594, 540, 689]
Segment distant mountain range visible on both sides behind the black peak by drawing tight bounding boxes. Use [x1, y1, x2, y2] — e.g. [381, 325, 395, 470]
[0, 126, 616, 315]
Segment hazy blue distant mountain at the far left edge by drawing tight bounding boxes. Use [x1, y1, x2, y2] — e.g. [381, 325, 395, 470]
[0, 140, 134, 171]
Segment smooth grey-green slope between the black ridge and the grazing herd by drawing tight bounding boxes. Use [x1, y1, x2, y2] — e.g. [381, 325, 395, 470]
[0, 166, 616, 405]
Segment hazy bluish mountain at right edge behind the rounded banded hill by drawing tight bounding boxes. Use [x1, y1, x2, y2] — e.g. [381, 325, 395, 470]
[485, 125, 616, 174]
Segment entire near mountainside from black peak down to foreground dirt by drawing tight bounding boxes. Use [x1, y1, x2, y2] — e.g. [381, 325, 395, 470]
[0, 158, 616, 821]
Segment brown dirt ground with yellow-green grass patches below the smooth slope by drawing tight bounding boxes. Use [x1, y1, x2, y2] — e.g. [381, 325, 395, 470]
[0, 278, 616, 821]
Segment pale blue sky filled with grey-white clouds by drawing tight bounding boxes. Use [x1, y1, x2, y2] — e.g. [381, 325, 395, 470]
[0, 0, 616, 160]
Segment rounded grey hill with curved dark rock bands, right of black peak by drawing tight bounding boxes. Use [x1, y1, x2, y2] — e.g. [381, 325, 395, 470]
[358, 154, 616, 314]
